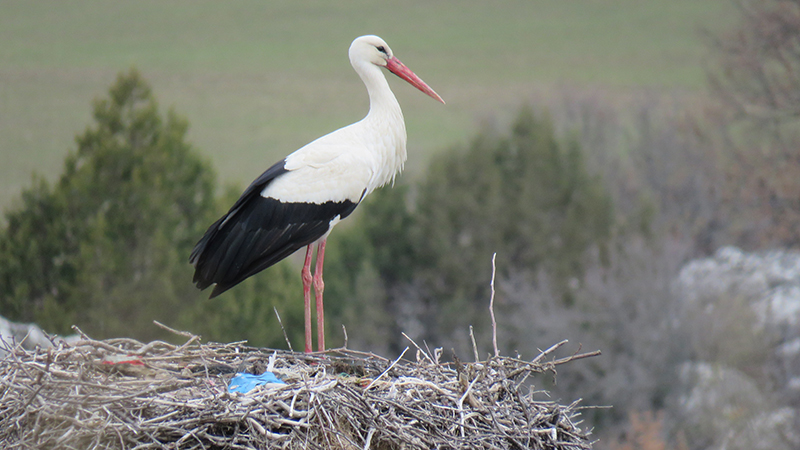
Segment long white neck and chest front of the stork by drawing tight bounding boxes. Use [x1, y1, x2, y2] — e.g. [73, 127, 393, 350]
[354, 63, 407, 187]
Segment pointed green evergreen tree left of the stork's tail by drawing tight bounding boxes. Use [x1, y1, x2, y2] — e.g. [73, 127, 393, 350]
[0, 70, 215, 338]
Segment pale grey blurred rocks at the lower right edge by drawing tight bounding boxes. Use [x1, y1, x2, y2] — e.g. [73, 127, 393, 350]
[674, 247, 800, 450]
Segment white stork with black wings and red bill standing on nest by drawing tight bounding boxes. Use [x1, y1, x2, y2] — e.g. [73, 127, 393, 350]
[189, 36, 444, 353]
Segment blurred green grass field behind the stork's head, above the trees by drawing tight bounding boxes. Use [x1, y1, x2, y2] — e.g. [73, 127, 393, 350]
[0, 0, 735, 208]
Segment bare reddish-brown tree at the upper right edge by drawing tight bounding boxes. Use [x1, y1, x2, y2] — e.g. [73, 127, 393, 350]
[709, 0, 800, 248]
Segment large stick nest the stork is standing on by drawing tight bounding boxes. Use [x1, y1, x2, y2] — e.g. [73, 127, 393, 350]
[0, 326, 594, 450]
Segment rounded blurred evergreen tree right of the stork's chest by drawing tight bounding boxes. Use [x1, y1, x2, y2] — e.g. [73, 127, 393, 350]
[413, 108, 613, 338]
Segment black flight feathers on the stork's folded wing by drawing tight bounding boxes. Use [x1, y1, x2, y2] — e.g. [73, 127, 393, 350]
[189, 161, 358, 298]
